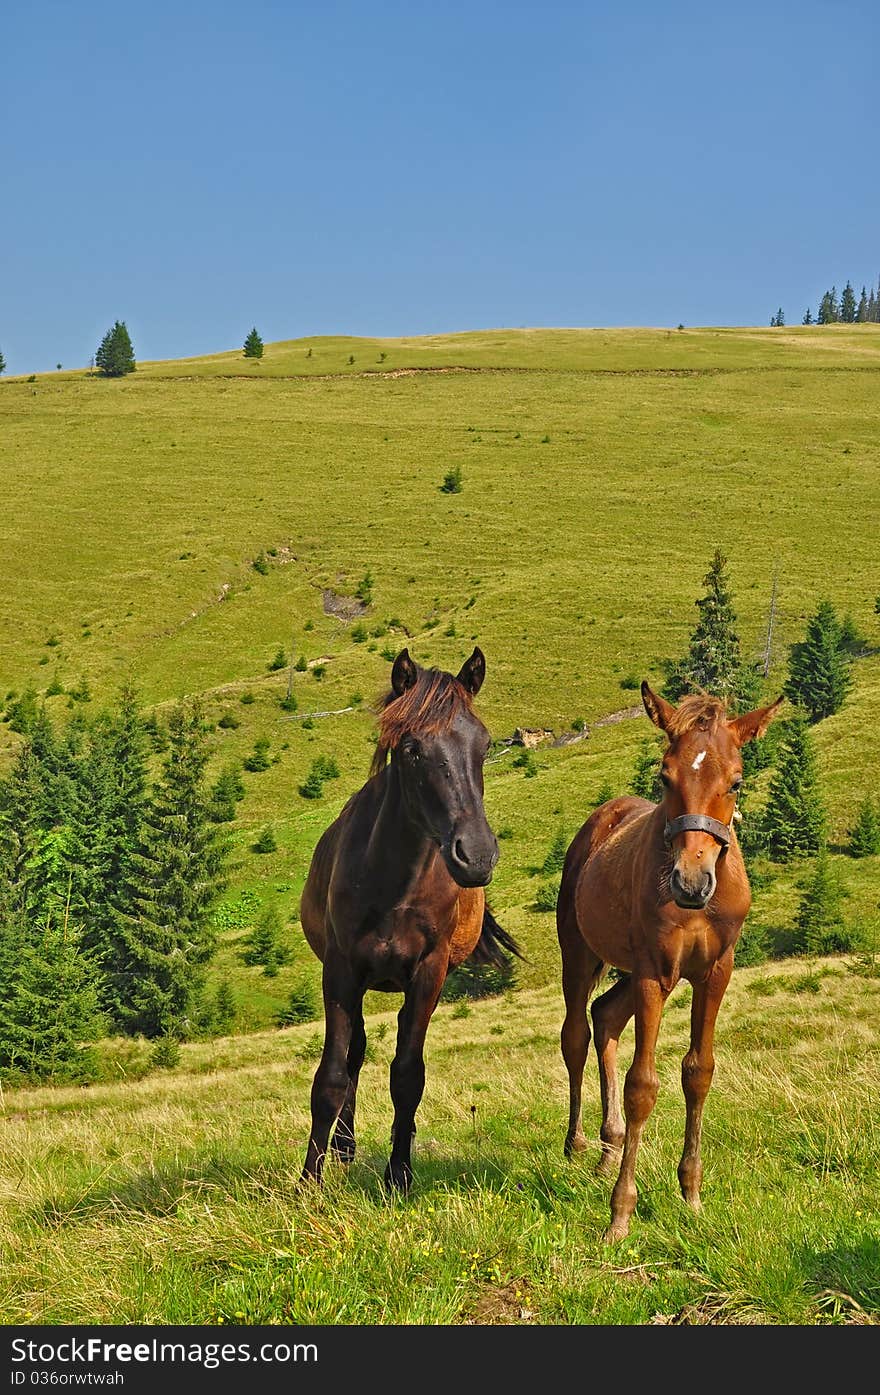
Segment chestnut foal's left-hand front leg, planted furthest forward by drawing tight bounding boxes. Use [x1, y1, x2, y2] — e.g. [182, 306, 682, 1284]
[605, 975, 668, 1240]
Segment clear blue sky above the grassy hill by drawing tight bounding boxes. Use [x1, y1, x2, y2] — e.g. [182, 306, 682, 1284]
[0, 0, 880, 372]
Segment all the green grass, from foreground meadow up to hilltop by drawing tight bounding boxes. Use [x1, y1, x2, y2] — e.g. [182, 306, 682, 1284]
[0, 325, 880, 1324]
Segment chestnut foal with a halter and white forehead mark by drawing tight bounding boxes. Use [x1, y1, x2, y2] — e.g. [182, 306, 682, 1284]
[556, 682, 782, 1240]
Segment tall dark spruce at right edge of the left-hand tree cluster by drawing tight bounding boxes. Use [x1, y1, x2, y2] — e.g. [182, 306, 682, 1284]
[113, 703, 229, 1036]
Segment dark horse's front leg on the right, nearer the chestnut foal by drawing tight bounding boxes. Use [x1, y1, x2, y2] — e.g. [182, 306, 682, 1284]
[385, 944, 449, 1191]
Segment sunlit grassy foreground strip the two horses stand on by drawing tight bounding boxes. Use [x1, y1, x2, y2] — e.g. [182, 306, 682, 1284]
[0, 960, 880, 1325]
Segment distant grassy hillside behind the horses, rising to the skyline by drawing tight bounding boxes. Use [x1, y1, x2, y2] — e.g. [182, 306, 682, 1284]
[0, 325, 880, 1027]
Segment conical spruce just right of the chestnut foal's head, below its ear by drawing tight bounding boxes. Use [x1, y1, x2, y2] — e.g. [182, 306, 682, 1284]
[763, 711, 826, 862]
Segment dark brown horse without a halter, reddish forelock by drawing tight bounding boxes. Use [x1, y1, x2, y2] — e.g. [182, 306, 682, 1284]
[301, 649, 519, 1190]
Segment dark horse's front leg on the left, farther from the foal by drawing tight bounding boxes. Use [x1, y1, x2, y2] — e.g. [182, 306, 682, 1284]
[301, 950, 364, 1182]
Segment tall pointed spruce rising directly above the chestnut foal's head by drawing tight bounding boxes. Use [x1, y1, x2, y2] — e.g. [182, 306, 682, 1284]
[664, 548, 759, 707]
